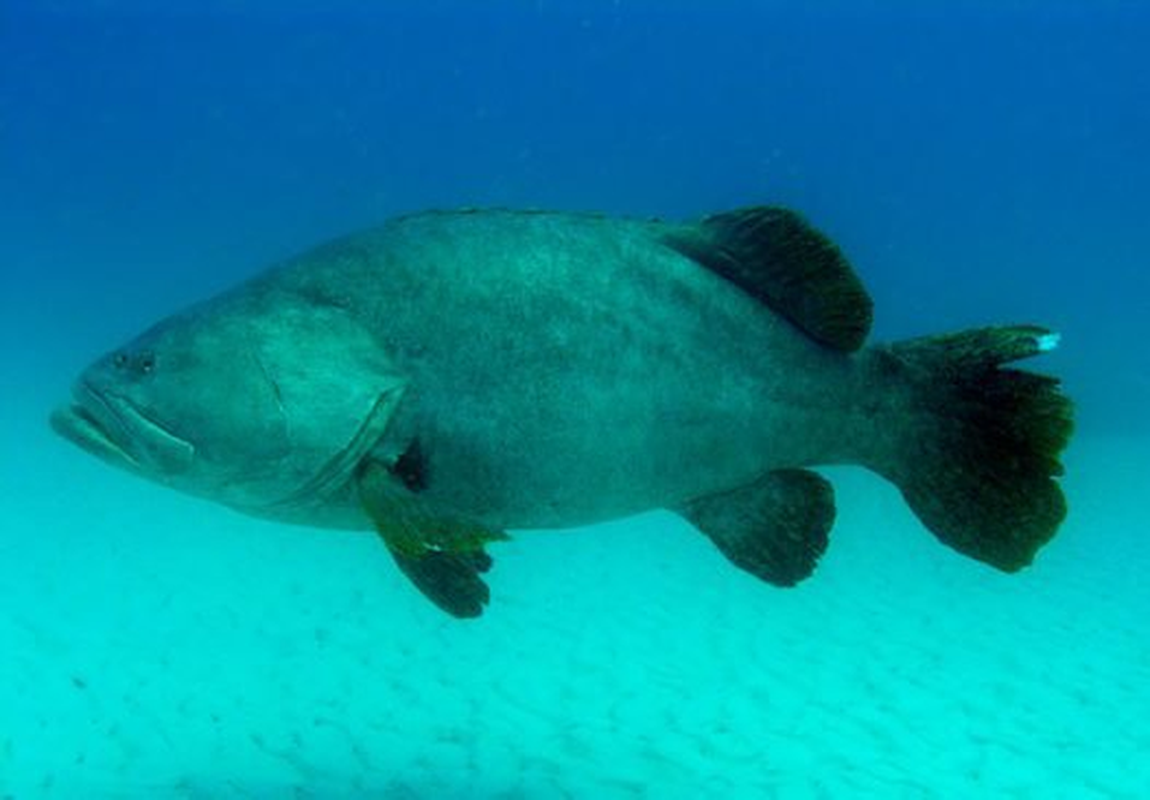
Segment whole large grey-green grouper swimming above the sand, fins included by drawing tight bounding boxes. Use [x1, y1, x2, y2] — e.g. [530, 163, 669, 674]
[53, 207, 1072, 617]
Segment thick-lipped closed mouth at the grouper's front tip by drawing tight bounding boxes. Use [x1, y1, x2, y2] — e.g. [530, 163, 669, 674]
[49, 382, 196, 472]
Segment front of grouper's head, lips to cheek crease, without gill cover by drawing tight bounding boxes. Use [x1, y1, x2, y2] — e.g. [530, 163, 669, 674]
[52, 298, 288, 494]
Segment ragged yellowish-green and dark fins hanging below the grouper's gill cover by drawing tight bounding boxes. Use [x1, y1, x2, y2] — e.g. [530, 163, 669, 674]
[359, 461, 507, 617]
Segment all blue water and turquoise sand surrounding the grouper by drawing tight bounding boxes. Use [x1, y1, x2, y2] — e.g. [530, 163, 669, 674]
[0, 0, 1150, 800]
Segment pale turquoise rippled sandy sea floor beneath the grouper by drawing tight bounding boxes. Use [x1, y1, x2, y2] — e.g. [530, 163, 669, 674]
[0, 415, 1150, 799]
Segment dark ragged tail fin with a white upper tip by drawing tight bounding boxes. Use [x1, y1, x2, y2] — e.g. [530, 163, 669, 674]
[873, 325, 1073, 572]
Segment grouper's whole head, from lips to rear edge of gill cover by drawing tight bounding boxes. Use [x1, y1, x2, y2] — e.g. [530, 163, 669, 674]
[52, 290, 407, 515]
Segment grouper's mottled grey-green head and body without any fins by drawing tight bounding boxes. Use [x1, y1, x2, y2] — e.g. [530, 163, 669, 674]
[54, 211, 878, 529]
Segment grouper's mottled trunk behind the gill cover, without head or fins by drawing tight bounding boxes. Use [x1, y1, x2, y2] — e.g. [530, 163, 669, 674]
[258, 213, 859, 528]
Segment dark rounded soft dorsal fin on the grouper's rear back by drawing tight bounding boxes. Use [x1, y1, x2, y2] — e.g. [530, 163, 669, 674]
[667, 206, 873, 351]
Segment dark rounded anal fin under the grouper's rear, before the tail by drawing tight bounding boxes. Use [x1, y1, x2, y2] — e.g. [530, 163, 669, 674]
[679, 469, 835, 586]
